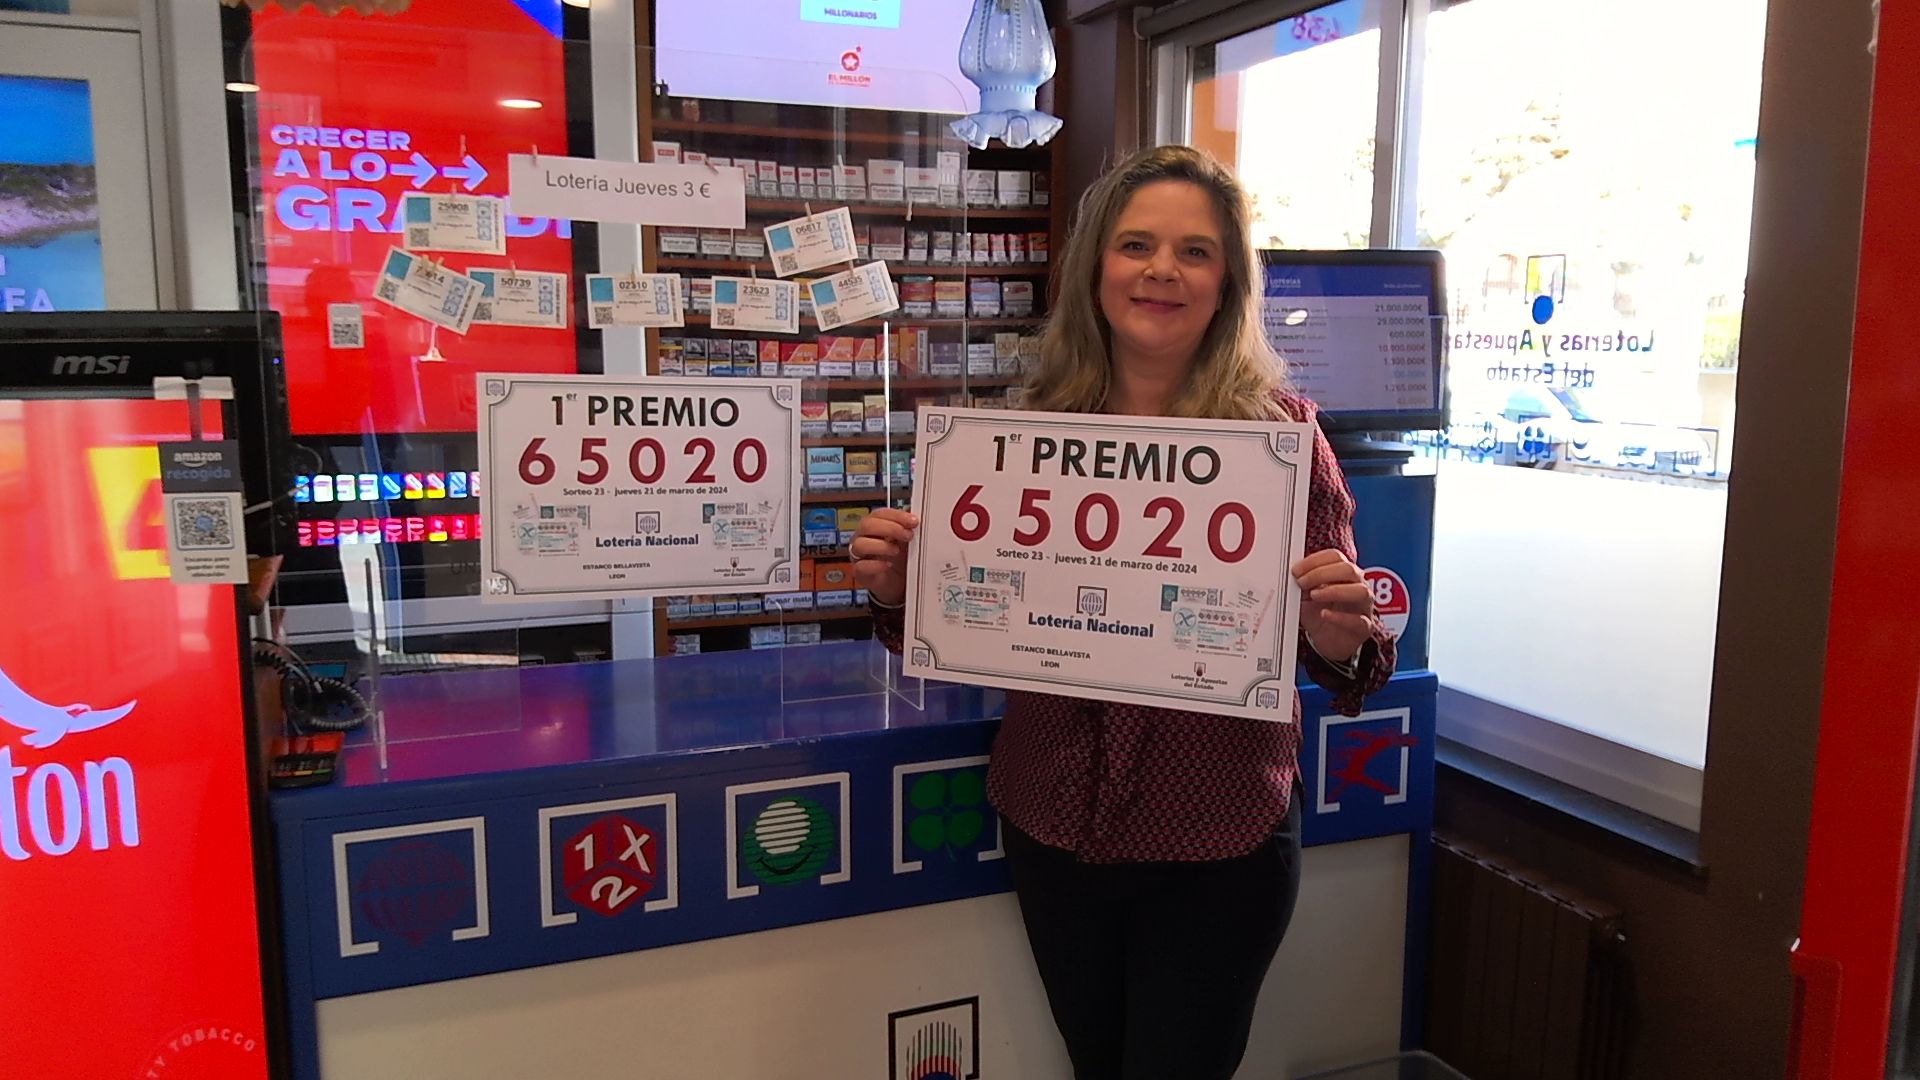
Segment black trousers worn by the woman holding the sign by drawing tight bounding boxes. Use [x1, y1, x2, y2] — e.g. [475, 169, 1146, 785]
[1002, 792, 1300, 1080]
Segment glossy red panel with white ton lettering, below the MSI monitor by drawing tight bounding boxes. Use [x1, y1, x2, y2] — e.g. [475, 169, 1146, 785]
[0, 400, 267, 1080]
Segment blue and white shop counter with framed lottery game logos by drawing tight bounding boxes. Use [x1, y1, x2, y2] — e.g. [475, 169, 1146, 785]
[273, 642, 1434, 1080]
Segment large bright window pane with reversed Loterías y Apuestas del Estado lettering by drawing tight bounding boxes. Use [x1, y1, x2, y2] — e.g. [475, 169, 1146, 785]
[1420, 0, 1766, 769]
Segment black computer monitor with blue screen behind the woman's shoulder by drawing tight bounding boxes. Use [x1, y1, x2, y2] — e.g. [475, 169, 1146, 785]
[1260, 250, 1448, 432]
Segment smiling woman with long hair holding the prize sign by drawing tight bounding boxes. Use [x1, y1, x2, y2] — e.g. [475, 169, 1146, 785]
[851, 146, 1394, 1080]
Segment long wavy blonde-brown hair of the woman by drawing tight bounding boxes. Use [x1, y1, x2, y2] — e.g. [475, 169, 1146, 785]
[1027, 146, 1292, 421]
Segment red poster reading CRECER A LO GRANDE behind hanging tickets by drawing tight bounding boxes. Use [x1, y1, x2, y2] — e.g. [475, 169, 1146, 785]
[252, 0, 576, 434]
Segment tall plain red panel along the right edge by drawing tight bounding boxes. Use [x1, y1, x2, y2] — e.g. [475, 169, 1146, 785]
[1788, 4, 1920, 1080]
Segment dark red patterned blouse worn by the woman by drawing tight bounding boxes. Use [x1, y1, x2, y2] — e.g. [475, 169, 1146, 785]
[874, 394, 1394, 863]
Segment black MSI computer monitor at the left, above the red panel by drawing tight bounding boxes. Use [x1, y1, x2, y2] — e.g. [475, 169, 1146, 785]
[0, 311, 294, 555]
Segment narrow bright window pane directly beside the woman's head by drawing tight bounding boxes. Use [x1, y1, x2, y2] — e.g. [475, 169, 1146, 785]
[1187, 0, 1380, 248]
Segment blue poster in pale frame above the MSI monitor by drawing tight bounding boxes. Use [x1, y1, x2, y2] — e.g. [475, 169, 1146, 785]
[0, 21, 159, 315]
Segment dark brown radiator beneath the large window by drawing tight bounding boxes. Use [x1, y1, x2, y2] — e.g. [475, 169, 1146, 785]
[1427, 834, 1632, 1080]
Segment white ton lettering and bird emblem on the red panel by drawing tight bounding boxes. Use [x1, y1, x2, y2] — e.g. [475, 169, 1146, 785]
[0, 671, 140, 863]
